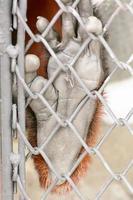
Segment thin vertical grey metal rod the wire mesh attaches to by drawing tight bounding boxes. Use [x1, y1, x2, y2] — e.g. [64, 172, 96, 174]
[17, 0, 27, 200]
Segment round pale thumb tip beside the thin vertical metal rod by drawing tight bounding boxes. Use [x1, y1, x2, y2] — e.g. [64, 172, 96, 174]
[25, 54, 40, 73]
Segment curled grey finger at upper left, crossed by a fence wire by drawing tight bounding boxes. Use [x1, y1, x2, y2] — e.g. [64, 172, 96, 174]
[36, 17, 59, 49]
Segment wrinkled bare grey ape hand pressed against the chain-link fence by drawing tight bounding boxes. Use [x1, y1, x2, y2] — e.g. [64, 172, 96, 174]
[26, 0, 104, 191]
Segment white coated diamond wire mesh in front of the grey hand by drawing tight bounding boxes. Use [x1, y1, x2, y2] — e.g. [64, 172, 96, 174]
[1, 0, 133, 200]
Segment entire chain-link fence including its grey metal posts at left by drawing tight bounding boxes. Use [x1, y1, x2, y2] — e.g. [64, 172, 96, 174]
[0, 0, 133, 200]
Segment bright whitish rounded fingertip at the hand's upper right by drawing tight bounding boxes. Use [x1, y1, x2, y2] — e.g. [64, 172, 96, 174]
[85, 16, 103, 35]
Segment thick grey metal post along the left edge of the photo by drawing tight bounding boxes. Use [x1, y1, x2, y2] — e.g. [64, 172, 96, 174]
[0, 0, 13, 200]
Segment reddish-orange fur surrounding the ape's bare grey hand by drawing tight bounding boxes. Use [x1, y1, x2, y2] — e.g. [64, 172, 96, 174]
[26, 0, 106, 193]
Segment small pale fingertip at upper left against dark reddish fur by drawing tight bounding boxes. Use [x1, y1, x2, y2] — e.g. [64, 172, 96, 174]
[36, 16, 49, 33]
